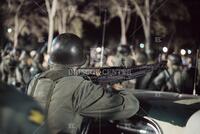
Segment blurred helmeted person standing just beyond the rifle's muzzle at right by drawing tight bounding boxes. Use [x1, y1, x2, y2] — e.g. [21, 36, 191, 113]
[153, 54, 184, 92]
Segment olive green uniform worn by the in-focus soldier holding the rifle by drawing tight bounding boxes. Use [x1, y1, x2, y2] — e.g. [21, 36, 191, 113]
[28, 65, 139, 134]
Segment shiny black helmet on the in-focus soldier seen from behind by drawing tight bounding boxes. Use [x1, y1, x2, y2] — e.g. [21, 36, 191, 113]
[50, 33, 86, 66]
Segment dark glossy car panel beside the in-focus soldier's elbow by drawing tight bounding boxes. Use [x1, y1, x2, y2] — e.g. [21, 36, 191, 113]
[134, 90, 200, 126]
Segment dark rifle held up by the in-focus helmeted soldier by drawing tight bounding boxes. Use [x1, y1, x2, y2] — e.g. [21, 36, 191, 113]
[78, 61, 167, 85]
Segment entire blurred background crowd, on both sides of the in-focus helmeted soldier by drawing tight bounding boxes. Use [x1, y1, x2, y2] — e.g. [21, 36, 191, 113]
[0, 38, 198, 94]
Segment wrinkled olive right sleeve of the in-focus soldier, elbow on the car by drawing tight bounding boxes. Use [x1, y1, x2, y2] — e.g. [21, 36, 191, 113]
[72, 81, 139, 120]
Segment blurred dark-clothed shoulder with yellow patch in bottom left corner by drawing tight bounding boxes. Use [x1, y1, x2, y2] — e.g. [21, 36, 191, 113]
[0, 83, 48, 134]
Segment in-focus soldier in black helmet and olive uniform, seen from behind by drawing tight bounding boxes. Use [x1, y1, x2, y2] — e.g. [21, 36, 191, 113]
[28, 33, 139, 134]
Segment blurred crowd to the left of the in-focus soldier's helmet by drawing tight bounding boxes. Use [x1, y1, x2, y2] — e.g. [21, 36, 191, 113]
[0, 45, 47, 92]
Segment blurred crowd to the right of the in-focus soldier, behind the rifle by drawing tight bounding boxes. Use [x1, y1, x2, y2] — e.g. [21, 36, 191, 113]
[93, 45, 199, 94]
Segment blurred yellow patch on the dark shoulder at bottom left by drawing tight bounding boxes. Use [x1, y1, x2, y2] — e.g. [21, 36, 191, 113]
[28, 109, 45, 125]
